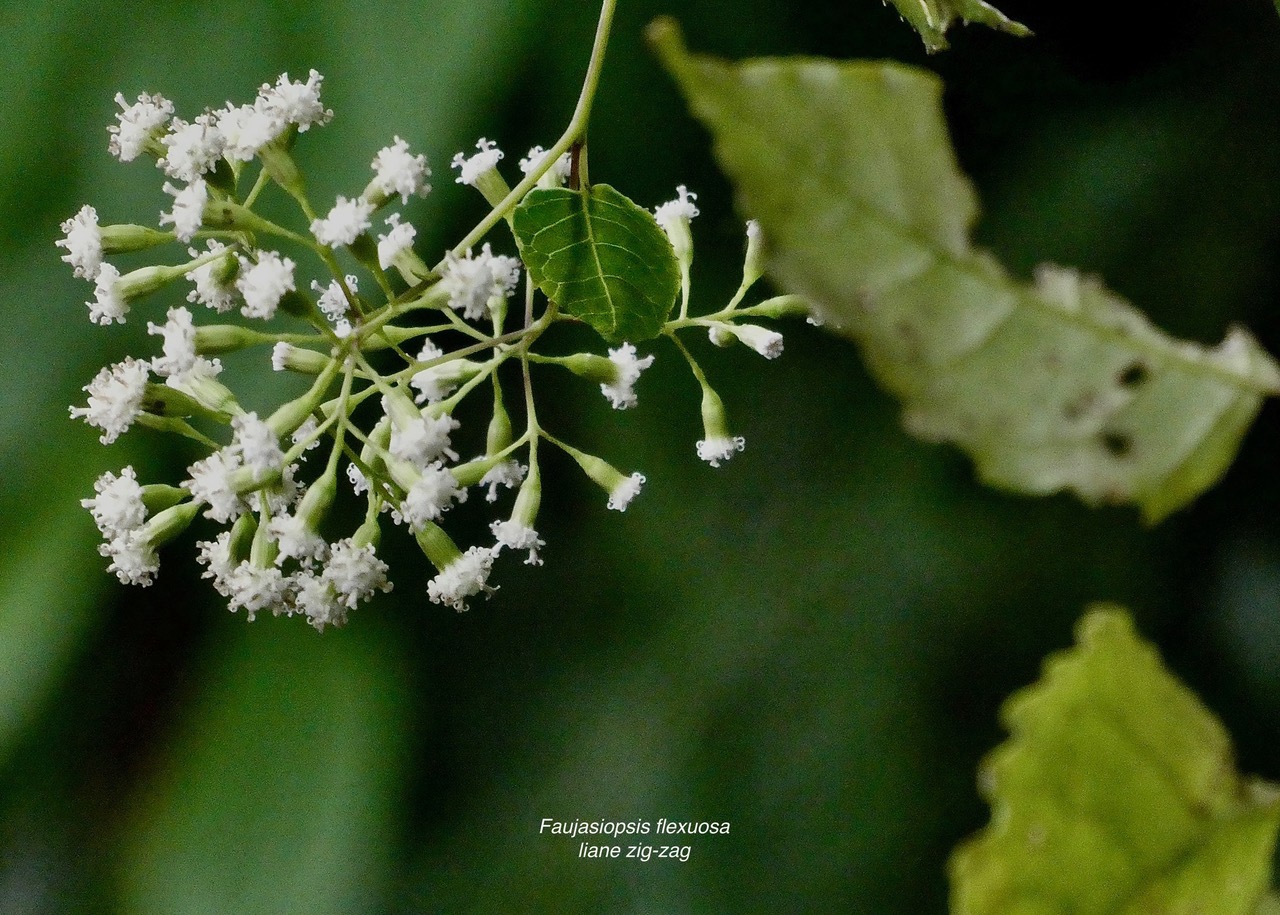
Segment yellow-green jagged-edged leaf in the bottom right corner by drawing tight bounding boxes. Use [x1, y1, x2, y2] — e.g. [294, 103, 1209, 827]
[950, 607, 1280, 915]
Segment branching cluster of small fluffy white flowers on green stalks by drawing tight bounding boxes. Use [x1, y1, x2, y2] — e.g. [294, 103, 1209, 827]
[58, 70, 795, 630]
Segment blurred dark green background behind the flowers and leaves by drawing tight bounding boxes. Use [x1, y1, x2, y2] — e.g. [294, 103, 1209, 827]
[0, 0, 1280, 915]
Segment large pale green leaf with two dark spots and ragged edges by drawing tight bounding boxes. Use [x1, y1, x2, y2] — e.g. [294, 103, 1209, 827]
[650, 22, 1280, 521]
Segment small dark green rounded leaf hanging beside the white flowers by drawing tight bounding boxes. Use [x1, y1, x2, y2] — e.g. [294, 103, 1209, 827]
[512, 184, 680, 343]
